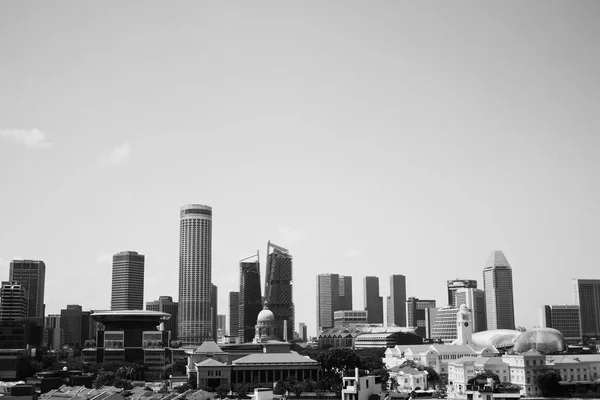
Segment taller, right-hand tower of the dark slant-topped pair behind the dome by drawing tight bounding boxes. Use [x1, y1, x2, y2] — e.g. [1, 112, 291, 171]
[265, 242, 296, 341]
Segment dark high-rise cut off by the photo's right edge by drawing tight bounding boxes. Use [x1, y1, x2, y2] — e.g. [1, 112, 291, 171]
[573, 279, 600, 338]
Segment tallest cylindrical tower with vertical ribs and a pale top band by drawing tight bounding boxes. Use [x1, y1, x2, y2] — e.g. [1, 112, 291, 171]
[177, 204, 212, 345]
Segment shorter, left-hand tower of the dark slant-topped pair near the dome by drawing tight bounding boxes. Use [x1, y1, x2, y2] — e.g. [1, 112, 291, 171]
[238, 255, 263, 343]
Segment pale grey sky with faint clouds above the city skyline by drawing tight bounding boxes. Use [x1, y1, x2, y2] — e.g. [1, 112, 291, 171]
[0, 0, 600, 335]
